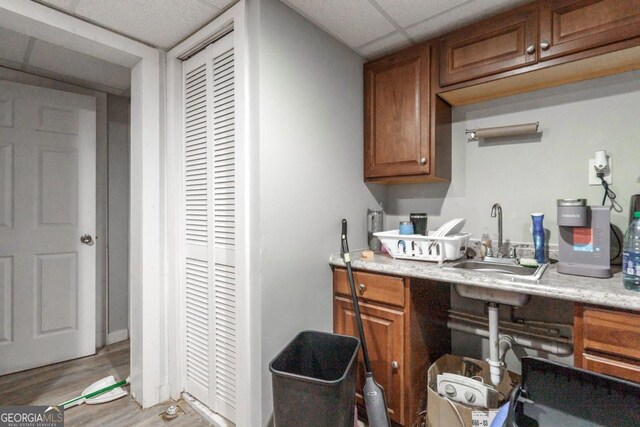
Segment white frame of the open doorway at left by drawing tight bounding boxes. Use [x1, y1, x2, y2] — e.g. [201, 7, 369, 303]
[0, 0, 168, 408]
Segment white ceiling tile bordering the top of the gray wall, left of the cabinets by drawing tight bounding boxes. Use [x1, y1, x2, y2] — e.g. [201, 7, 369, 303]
[282, 0, 395, 49]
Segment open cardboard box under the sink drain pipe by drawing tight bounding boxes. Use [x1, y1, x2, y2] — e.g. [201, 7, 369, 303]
[427, 354, 520, 427]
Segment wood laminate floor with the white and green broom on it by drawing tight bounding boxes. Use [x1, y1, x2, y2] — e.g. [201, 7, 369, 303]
[0, 341, 210, 427]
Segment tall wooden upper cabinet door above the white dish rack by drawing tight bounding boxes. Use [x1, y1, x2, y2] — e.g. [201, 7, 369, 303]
[364, 45, 430, 179]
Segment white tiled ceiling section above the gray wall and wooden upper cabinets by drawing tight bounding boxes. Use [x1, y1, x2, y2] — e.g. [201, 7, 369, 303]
[281, 0, 531, 59]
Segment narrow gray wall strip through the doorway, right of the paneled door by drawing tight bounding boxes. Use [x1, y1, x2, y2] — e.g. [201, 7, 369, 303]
[107, 95, 130, 341]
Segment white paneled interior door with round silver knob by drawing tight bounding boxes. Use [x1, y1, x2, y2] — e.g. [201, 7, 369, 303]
[0, 81, 96, 375]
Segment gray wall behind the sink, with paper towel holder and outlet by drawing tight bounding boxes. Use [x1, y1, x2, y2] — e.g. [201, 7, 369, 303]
[386, 71, 640, 243]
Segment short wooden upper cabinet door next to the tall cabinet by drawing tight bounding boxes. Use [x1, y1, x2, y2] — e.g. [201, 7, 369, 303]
[440, 3, 538, 86]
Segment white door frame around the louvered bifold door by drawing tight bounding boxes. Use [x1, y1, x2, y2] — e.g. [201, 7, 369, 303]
[165, 0, 262, 426]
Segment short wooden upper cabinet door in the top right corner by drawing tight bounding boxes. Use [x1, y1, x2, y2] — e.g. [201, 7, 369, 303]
[540, 0, 640, 60]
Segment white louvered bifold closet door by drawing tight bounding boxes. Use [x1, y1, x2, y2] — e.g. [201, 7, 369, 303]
[183, 34, 237, 422]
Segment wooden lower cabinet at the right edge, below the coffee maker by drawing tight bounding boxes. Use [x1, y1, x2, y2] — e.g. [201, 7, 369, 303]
[574, 304, 640, 383]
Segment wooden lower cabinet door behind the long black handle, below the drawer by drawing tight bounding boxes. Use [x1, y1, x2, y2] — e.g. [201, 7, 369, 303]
[333, 297, 405, 424]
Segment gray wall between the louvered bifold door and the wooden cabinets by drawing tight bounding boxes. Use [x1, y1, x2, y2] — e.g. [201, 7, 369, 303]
[259, 0, 376, 425]
